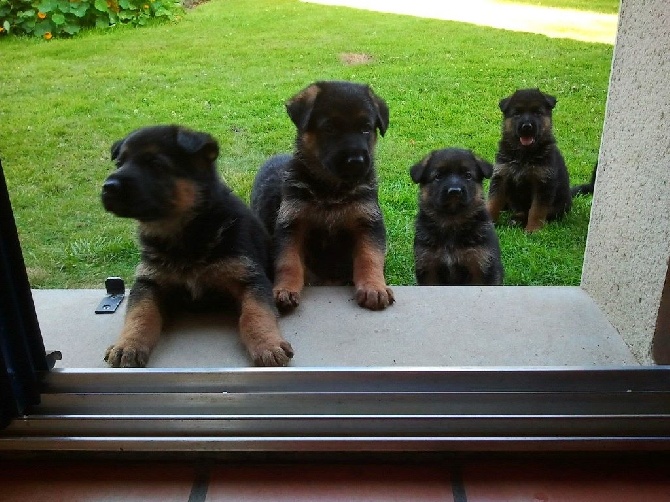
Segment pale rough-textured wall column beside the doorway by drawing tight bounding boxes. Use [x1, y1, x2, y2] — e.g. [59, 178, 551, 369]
[582, 0, 670, 364]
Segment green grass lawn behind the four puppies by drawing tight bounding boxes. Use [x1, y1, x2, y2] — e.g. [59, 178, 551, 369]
[0, 0, 612, 288]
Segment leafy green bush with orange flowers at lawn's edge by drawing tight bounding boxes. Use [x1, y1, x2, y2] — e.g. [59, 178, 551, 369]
[0, 0, 183, 40]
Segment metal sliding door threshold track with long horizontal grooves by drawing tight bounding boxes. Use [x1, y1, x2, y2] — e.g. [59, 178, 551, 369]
[0, 367, 670, 453]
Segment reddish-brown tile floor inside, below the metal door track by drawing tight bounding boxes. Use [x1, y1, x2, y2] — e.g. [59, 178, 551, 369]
[0, 458, 670, 502]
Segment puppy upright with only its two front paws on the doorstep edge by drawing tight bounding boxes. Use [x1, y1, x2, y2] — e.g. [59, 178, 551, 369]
[251, 82, 394, 311]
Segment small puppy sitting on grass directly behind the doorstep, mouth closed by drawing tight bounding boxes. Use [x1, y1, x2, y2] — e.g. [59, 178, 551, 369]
[410, 148, 503, 286]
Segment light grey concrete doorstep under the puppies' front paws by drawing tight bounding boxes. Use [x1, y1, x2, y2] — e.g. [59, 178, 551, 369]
[33, 286, 638, 368]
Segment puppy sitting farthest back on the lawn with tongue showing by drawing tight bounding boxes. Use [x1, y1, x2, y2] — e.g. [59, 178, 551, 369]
[488, 89, 572, 232]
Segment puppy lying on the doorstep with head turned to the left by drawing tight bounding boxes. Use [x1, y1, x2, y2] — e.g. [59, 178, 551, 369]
[102, 125, 293, 367]
